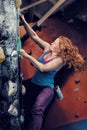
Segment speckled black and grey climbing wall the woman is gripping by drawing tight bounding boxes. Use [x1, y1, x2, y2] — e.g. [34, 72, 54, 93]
[0, 0, 20, 130]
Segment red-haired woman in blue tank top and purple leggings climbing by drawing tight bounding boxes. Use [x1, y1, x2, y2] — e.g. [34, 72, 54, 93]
[20, 15, 85, 130]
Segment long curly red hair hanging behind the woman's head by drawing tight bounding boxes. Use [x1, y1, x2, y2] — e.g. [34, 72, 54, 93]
[59, 36, 85, 71]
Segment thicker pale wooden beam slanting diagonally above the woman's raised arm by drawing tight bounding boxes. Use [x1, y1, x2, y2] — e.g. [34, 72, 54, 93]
[37, 0, 66, 26]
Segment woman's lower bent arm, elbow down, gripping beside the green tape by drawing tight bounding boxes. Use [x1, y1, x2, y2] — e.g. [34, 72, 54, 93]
[20, 49, 63, 72]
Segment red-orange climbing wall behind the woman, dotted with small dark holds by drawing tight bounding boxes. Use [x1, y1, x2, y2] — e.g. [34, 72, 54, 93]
[20, 17, 87, 130]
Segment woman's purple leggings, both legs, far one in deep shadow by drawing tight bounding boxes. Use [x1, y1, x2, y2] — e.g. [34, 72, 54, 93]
[23, 83, 54, 130]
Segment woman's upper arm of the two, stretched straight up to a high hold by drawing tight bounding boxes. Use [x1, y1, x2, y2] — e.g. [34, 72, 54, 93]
[20, 14, 50, 50]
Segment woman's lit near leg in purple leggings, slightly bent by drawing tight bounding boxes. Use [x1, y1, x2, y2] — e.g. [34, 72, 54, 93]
[28, 87, 54, 130]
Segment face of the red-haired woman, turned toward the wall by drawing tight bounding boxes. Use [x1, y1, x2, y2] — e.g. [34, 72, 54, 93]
[50, 38, 60, 54]
